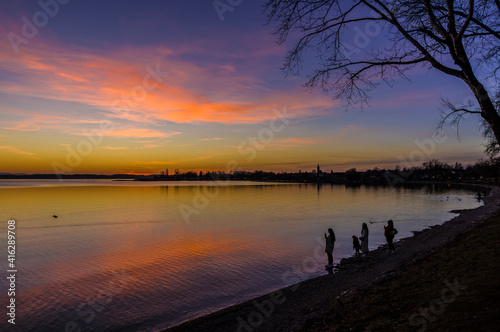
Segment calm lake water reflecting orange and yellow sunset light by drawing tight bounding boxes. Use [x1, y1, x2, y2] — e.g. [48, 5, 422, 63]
[0, 180, 480, 331]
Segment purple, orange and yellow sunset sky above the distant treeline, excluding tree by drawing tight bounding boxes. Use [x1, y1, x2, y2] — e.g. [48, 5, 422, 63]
[0, 0, 492, 174]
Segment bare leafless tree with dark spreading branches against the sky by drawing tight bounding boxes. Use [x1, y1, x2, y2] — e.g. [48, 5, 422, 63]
[264, 0, 500, 143]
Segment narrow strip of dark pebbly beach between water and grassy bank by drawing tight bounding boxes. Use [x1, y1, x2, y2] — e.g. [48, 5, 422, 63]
[161, 183, 500, 332]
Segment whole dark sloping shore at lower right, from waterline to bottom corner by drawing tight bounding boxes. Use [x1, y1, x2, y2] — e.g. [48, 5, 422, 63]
[164, 187, 500, 332]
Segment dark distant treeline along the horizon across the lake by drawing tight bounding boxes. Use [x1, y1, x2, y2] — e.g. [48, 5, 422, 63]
[0, 157, 500, 186]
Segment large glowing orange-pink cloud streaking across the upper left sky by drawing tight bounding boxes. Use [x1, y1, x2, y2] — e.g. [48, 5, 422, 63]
[0, 34, 334, 131]
